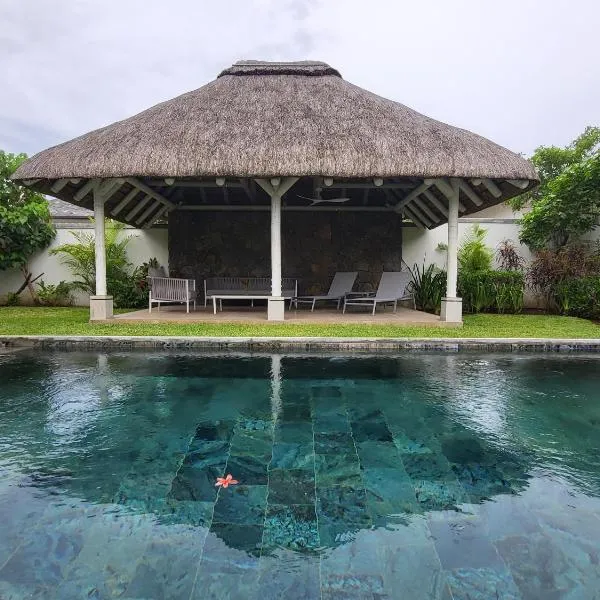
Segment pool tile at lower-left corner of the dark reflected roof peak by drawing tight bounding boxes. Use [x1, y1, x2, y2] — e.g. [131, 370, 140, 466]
[201, 522, 264, 560]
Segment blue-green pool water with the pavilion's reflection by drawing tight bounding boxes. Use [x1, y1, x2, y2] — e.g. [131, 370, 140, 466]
[0, 351, 600, 600]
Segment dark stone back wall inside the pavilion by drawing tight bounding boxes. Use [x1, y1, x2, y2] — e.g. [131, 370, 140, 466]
[169, 211, 402, 293]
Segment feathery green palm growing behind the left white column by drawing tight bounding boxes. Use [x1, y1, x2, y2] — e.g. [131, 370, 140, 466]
[50, 220, 148, 308]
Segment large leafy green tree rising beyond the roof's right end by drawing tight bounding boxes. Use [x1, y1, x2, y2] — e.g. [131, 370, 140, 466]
[510, 127, 600, 250]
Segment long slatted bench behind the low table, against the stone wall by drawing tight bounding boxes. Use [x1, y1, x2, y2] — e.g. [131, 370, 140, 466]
[204, 277, 298, 312]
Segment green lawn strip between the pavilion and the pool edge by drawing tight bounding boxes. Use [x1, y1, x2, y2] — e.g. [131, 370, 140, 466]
[0, 307, 600, 339]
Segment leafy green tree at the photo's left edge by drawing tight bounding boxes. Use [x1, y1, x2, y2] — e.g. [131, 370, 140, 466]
[0, 150, 56, 294]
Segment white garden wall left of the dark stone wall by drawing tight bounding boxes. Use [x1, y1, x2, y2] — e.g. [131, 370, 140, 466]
[0, 221, 169, 306]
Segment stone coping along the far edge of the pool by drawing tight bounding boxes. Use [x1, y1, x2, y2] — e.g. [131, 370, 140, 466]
[0, 335, 600, 354]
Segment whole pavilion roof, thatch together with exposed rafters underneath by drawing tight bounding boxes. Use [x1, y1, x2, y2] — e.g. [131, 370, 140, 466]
[14, 61, 538, 322]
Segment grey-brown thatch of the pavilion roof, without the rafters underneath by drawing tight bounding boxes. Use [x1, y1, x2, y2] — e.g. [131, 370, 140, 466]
[14, 61, 537, 229]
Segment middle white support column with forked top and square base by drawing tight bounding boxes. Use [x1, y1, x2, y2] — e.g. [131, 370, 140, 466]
[256, 177, 298, 321]
